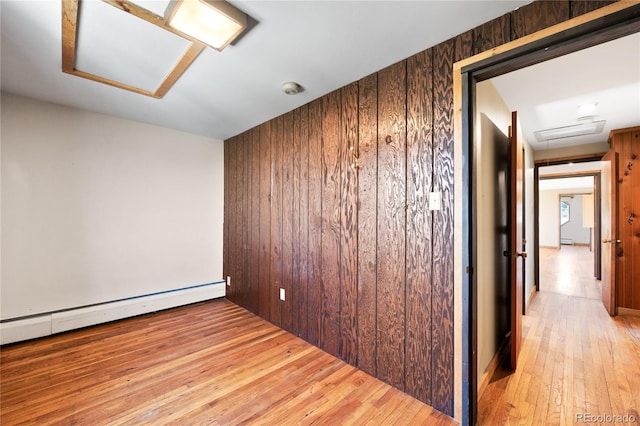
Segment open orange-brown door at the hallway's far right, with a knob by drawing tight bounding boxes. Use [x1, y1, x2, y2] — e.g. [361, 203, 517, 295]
[600, 150, 619, 315]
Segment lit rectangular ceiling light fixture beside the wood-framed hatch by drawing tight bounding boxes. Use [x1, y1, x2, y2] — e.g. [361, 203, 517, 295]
[165, 0, 247, 51]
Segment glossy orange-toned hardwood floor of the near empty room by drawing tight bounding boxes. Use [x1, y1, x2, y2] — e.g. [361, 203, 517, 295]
[0, 299, 455, 426]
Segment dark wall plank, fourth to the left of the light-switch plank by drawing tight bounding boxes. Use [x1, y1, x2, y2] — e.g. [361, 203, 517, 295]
[339, 83, 358, 365]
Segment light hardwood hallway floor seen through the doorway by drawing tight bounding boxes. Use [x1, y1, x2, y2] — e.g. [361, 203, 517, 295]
[478, 246, 640, 425]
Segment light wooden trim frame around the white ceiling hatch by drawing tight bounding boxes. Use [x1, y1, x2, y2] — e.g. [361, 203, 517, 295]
[62, 0, 206, 99]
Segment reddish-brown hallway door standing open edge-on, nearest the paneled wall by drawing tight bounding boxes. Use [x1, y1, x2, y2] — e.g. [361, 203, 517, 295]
[509, 111, 527, 370]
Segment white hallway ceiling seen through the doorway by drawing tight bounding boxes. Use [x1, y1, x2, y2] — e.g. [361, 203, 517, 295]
[492, 33, 640, 150]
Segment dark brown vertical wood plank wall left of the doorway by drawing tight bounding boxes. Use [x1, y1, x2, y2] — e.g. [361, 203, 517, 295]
[224, 0, 610, 415]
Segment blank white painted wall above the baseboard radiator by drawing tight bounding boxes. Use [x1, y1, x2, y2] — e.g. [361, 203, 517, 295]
[0, 93, 224, 319]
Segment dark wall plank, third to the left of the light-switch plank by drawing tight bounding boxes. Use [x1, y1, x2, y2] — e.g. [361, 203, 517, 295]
[357, 74, 378, 376]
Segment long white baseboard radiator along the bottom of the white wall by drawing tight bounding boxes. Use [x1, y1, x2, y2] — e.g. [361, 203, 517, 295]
[0, 281, 226, 345]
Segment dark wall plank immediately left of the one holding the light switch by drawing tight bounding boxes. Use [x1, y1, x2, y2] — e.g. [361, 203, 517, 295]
[405, 50, 433, 403]
